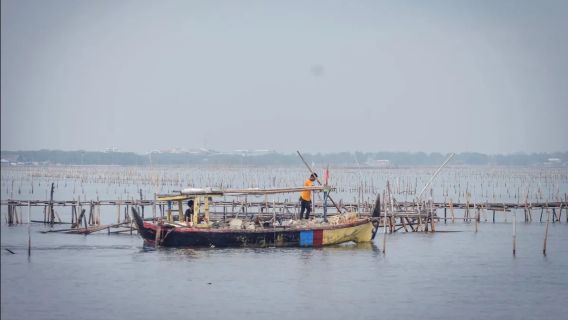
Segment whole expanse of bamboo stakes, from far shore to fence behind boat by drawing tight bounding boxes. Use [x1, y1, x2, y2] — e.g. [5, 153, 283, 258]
[1, 167, 568, 256]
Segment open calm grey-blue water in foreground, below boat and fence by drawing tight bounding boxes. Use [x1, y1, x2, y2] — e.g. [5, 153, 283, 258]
[1, 223, 568, 319]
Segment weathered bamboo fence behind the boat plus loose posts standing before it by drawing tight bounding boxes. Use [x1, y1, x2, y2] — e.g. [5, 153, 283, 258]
[1, 184, 568, 255]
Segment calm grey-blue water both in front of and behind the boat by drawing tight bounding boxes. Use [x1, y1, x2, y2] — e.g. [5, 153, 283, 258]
[0, 167, 568, 320]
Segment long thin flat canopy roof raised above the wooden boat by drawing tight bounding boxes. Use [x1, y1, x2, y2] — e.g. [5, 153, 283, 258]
[157, 186, 335, 201]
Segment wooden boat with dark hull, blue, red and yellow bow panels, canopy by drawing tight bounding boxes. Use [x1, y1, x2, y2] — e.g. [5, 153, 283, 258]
[132, 187, 376, 247]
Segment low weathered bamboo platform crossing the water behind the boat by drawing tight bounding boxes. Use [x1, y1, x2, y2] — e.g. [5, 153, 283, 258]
[0, 198, 568, 234]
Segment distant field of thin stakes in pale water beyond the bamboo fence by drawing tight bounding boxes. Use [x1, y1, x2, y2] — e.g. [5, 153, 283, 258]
[1, 166, 568, 203]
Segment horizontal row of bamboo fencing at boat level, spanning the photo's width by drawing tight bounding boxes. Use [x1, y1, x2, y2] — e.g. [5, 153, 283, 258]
[0, 192, 568, 232]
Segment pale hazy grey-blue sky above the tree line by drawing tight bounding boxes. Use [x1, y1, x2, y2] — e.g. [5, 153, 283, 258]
[1, 0, 568, 153]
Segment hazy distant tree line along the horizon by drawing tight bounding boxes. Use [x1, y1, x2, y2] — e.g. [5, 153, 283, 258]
[1, 150, 568, 167]
